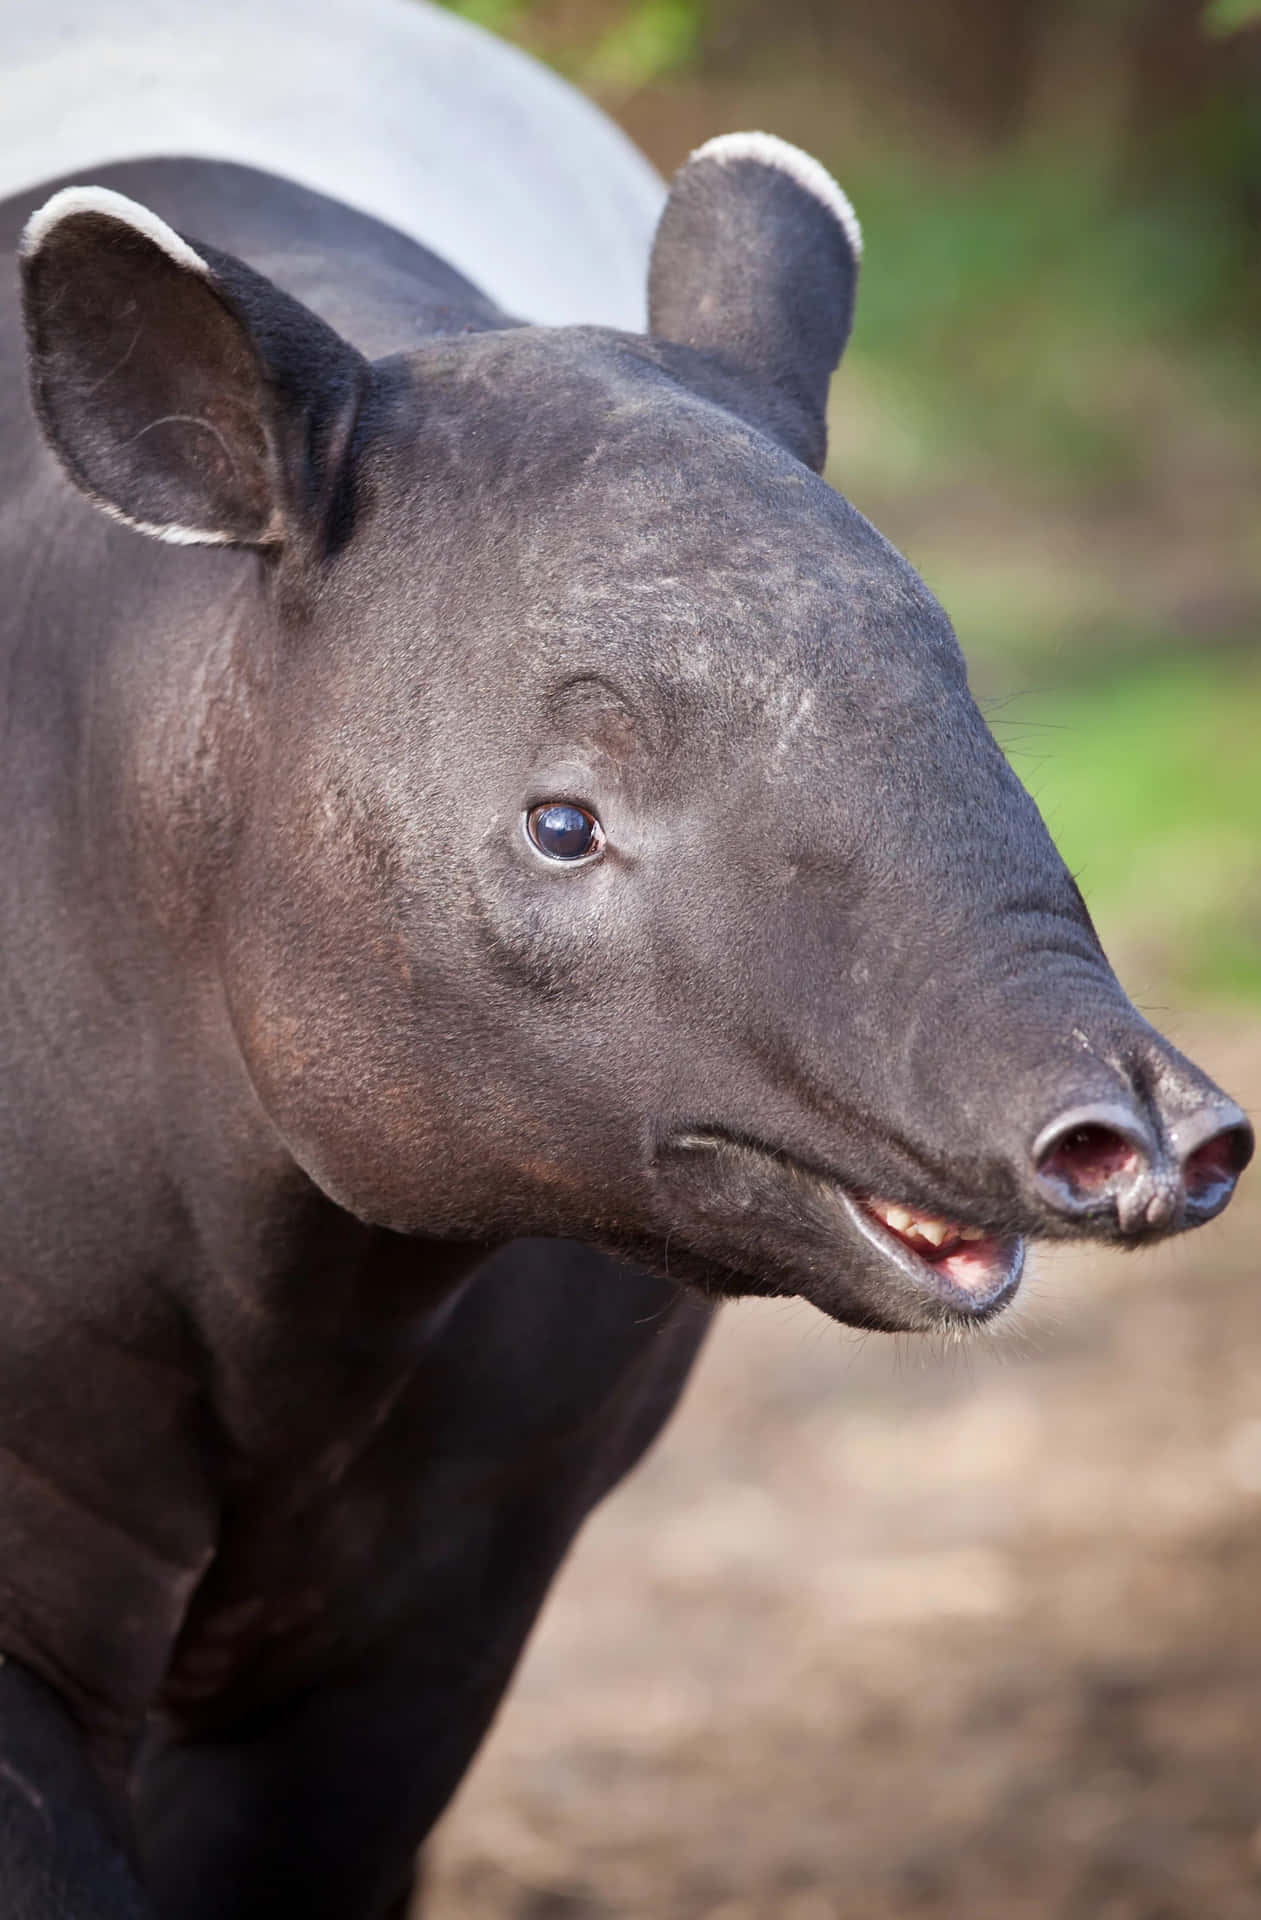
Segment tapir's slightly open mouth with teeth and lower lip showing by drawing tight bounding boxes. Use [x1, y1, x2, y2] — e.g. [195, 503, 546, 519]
[670, 1127, 1025, 1331]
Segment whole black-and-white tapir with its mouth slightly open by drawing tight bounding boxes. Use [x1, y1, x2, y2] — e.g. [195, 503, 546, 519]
[0, 0, 1251, 1920]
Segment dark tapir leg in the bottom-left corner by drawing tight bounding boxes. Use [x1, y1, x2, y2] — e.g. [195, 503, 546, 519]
[0, 1659, 154, 1920]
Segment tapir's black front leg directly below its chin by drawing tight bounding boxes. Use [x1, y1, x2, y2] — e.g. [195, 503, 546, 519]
[134, 1240, 708, 1920]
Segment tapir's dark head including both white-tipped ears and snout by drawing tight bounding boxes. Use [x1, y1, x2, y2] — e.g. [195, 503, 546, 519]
[23, 134, 1251, 1327]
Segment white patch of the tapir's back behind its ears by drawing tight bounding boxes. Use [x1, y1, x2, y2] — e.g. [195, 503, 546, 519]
[0, 0, 664, 328]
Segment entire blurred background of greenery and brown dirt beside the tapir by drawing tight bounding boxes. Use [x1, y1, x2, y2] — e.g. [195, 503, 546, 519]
[430, 0, 1261, 1920]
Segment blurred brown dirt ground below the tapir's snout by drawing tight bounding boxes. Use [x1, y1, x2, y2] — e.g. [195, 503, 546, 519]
[426, 1020, 1261, 1920]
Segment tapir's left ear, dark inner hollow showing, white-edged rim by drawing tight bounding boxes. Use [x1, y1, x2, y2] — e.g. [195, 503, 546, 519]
[21, 186, 369, 547]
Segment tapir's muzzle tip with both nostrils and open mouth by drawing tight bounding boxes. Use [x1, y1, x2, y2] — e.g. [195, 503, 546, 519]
[648, 975, 1253, 1329]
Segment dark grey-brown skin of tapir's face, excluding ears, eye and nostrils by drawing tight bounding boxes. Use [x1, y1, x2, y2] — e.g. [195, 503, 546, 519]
[230, 332, 1242, 1327]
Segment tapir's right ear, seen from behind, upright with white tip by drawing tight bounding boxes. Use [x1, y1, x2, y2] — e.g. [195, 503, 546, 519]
[649, 132, 862, 472]
